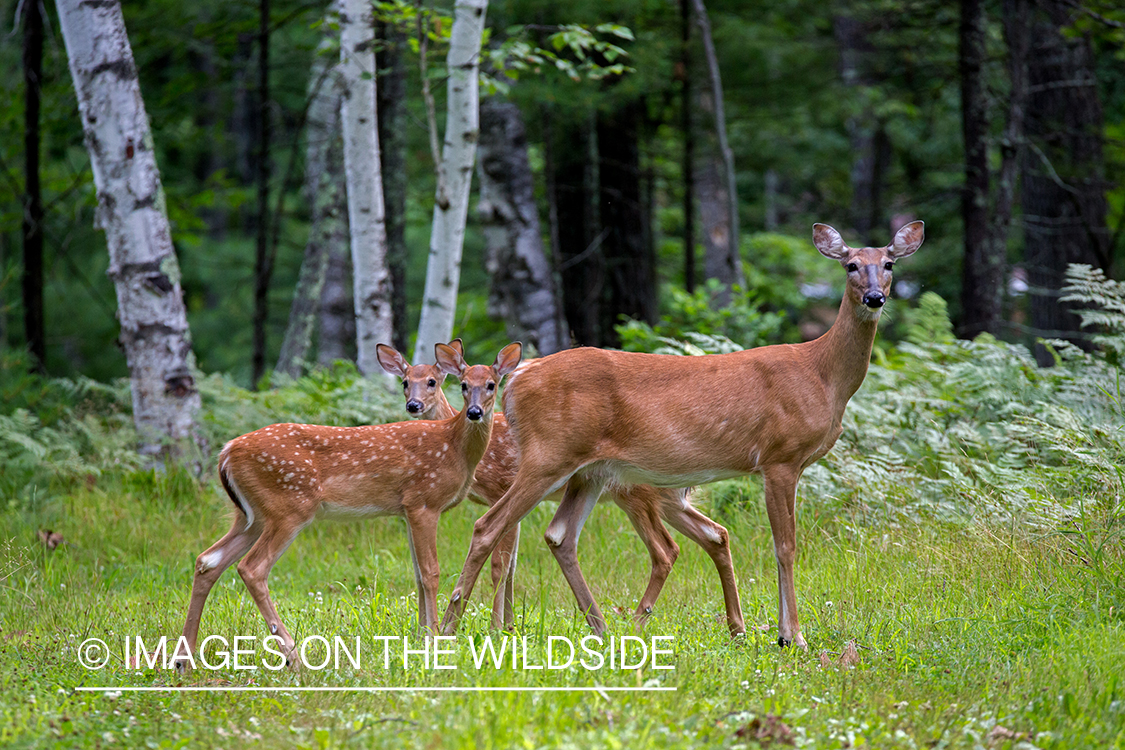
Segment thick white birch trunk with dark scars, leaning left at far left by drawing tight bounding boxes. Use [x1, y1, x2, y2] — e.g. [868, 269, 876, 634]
[57, 0, 199, 457]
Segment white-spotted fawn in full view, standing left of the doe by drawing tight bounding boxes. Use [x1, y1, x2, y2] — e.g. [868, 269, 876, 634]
[178, 344, 521, 666]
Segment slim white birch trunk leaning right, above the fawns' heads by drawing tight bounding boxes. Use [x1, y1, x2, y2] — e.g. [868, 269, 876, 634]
[412, 0, 488, 364]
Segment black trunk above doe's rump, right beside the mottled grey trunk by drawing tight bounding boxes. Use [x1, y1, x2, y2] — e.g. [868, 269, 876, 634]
[546, 112, 605, 346]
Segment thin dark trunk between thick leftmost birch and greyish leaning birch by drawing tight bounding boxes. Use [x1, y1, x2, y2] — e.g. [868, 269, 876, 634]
[251, 0, 273, 388]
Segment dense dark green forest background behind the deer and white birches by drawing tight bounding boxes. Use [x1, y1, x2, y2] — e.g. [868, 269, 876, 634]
[0, 0, 1125, 386]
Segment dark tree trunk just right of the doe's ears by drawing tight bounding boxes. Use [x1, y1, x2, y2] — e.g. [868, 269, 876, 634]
[959, 0, 1005, 338]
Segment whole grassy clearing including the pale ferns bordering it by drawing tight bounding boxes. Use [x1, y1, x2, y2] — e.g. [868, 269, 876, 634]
[0, 284, 1125, 749]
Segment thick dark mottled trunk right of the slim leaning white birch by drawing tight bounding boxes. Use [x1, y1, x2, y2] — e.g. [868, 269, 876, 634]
[477, 97, 569, 355]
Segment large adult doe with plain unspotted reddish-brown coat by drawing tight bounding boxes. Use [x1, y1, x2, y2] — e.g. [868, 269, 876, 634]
[443, 222, 923, 648]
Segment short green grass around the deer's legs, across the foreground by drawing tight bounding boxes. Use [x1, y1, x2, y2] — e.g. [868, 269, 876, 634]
[0, 465, 1125, 748]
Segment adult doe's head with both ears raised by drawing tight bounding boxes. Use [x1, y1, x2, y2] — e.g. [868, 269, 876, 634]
[812, 222, 925, 319]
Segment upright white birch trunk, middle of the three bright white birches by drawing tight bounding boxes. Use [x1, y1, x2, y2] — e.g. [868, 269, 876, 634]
[340, 0, 394, 377]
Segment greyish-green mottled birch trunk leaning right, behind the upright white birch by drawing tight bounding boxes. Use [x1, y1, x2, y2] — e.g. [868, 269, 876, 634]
[277, 24, 348, 378]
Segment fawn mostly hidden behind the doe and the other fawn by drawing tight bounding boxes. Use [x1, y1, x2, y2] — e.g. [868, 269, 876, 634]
[379, 338, 746, 634]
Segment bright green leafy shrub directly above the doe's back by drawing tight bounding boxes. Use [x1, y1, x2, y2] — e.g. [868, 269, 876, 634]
[615, 280, 783, 352]
